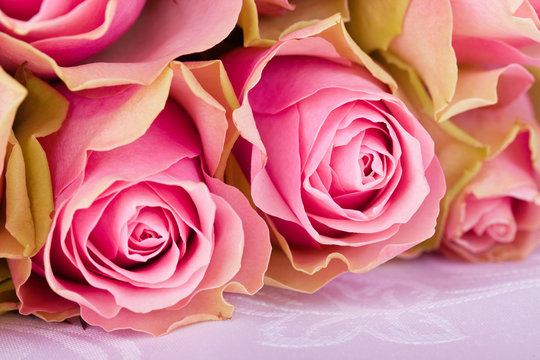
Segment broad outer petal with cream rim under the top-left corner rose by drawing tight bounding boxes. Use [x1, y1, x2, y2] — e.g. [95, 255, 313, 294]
[0, 0, 241, 91]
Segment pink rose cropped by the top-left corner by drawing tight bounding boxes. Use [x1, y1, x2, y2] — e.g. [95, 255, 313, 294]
[0, 0, 242, 90]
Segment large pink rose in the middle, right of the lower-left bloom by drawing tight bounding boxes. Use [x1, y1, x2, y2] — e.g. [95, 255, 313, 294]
[224, 16, 445, 291]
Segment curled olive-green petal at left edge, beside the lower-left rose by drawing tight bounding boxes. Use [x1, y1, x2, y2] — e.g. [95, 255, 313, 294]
[4, 74, 68, 257]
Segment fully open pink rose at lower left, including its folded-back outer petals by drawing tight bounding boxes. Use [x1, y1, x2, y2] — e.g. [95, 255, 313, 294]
[9, 61, 270, 335]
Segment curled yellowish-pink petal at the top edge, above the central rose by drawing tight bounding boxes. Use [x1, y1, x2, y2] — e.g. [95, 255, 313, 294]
[238, 0, 350, 46]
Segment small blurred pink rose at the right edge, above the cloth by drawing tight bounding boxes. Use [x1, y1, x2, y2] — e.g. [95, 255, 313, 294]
[440, 93, 540, 261]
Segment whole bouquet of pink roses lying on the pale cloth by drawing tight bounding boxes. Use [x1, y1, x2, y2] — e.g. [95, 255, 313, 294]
[0, 0, 540, 335]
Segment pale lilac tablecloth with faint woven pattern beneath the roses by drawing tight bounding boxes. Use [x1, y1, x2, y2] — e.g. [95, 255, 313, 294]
[0, 251, 540, 360]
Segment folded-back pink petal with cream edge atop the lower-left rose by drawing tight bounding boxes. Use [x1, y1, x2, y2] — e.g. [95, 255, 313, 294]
[42, 68, 172, 194]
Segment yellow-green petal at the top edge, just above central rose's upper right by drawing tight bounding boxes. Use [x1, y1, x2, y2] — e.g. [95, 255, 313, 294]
[347, 0, 410, 52]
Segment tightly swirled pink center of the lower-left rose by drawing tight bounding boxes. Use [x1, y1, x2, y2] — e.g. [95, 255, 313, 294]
[81, 184, 194, 281]
